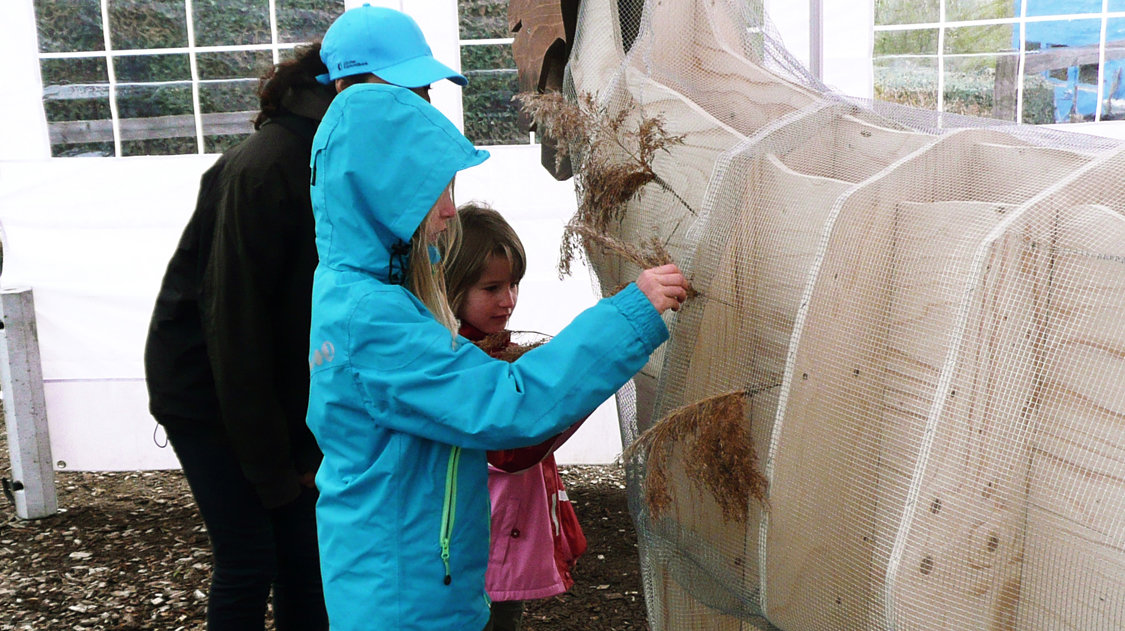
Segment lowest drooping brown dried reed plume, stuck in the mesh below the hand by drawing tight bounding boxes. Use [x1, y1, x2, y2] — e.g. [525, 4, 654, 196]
[623, 390, 767, 522]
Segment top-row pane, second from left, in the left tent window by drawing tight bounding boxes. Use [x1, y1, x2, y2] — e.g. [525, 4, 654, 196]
[109, 0, 188, 51]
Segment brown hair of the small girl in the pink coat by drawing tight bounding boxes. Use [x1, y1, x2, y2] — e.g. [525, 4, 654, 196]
[446, 201, 528, 314]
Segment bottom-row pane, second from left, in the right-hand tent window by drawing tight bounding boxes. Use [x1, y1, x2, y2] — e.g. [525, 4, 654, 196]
[944, 55, 1019, 123]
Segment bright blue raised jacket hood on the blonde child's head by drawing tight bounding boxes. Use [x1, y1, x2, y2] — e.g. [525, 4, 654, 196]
[312, 83, 488, 281]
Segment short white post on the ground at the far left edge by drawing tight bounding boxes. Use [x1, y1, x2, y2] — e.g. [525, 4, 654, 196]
[0, 288, 59, 520]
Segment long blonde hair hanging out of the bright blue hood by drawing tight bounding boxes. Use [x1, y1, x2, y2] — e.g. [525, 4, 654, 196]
[406, 200, 461, 335]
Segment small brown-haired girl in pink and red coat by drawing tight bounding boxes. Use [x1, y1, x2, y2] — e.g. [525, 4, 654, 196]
[446, 204, 586, 631]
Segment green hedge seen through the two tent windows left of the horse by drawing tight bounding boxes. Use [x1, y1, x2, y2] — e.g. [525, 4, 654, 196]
[35, 0, 529, 156]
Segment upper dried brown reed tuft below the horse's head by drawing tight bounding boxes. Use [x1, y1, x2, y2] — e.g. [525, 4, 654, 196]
[515, 92, 695, 276]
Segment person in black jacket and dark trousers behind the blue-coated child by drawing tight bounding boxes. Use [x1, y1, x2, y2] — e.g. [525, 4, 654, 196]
[145, 45, 335, 631]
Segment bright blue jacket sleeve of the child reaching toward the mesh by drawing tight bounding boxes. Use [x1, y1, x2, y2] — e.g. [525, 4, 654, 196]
[349, 285, 668, 450]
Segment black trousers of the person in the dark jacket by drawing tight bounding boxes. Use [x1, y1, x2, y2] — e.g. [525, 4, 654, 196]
[165, 424, 329, 631]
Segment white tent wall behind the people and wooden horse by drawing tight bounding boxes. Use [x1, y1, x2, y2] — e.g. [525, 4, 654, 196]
[0, 0, 1122, 470]
